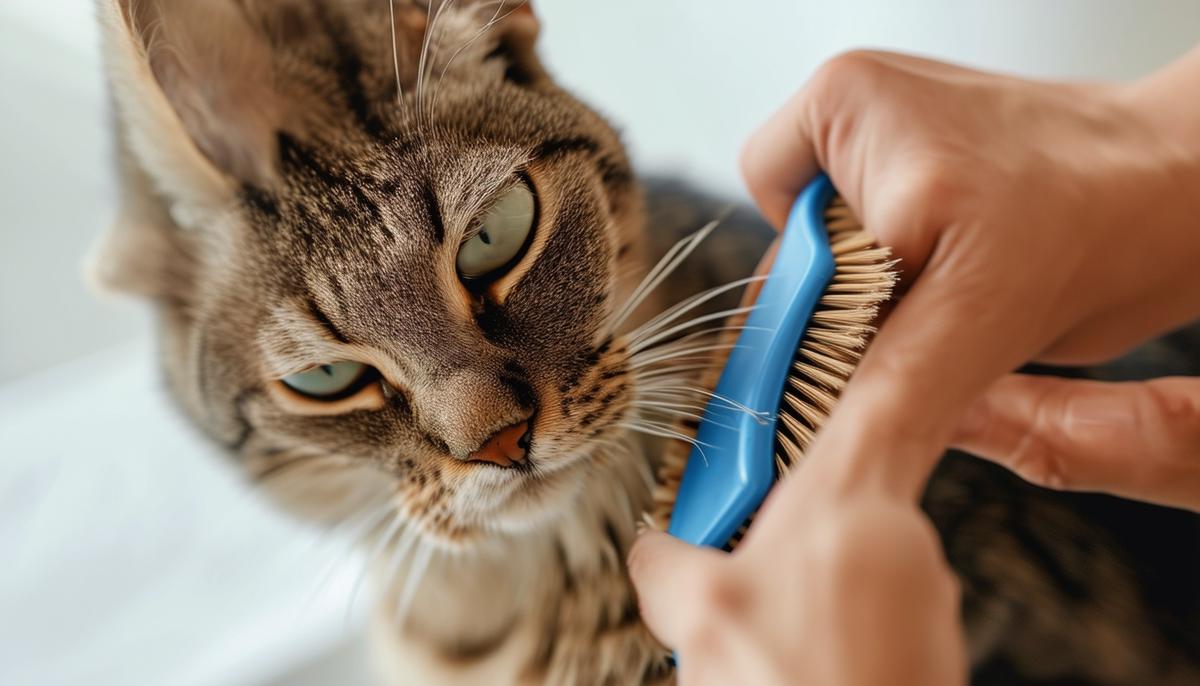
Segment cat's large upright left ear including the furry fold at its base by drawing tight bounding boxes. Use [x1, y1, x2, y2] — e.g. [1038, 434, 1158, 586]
[93, 0, 282, 301]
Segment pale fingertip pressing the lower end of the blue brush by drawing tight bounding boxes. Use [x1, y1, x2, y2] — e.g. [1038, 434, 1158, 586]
[629, 531, 726, 648]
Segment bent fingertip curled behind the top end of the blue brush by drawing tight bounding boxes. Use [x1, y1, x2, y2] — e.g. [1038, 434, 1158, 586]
[740, 90, 820, 229]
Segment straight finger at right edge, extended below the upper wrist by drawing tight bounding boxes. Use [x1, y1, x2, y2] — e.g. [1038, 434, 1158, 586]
[954, 374, 1200, 511]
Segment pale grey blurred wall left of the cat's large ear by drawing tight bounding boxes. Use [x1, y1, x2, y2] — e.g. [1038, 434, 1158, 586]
[0, 0, 139, 383]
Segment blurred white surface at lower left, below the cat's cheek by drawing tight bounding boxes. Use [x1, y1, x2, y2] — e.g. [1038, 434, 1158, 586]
[0, 344, 366, 686]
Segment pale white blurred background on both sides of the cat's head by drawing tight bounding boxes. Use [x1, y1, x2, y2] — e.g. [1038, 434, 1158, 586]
[0, 0, 1200, 686]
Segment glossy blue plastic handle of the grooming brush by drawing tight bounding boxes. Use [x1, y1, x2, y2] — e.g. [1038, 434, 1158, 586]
[667, 174, 835, 548]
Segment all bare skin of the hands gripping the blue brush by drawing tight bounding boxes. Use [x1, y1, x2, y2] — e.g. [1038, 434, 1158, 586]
[629, 49, 1200, 686]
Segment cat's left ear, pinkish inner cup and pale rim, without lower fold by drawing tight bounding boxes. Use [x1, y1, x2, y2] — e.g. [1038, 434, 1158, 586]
[101, 0, 283, 211]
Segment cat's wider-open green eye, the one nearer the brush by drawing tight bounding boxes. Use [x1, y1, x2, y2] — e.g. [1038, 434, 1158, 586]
[457, 183, 535, 278]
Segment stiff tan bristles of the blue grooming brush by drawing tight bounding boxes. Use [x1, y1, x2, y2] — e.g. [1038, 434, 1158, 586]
[647, 198, 898, 532]
